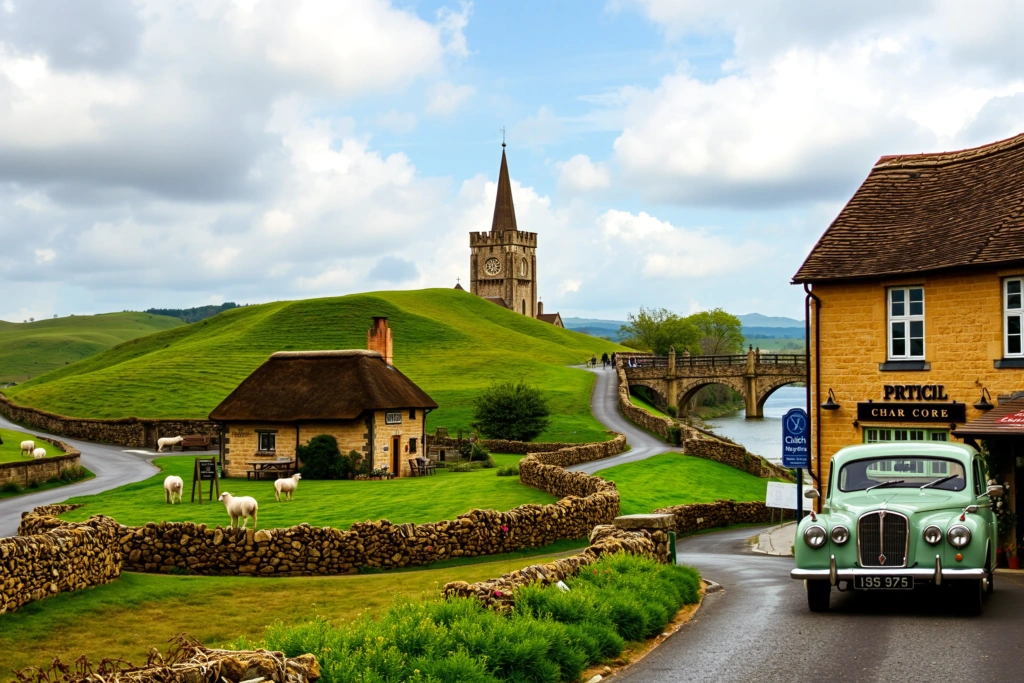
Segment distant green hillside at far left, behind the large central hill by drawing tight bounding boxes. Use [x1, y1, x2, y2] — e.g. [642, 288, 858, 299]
[0, 313, 183, 384]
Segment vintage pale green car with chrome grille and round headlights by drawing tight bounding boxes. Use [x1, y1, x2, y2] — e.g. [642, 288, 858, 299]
[791, 441, 1002, 613]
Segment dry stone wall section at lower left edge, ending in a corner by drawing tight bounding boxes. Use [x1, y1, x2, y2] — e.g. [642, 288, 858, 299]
[0, 516, 121, 614]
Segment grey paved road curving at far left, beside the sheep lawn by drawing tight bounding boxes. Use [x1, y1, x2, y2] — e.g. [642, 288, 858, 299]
[0, 417, 197, 539]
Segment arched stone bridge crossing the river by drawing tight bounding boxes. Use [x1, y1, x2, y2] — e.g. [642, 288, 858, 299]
[616, 347, 807, 418]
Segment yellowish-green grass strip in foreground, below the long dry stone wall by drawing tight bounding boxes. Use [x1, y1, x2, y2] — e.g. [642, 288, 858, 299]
[0, 548, 585, 680]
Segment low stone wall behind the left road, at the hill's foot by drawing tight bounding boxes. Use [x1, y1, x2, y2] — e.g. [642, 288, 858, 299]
[0, 394, 219, 449]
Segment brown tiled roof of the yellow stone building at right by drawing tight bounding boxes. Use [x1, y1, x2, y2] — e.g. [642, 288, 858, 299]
[793, 134, 1024, 283]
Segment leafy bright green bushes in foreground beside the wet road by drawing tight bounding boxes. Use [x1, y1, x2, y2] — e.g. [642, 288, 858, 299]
[242, 555, 700, 683]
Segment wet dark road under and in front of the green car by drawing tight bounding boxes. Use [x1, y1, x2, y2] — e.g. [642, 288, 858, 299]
[614, 528, 1024, 683]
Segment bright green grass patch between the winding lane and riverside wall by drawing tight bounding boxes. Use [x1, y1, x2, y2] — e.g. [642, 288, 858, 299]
[597, 453, 768, 515]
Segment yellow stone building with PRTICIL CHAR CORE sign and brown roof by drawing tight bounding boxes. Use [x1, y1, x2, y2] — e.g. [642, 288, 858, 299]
[793, 134, 1024, 533]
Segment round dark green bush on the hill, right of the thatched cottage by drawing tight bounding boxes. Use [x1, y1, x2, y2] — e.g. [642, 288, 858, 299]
[473, 380, 551, 441]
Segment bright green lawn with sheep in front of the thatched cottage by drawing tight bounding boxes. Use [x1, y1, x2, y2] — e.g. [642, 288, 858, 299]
[62, 456, 557, 528]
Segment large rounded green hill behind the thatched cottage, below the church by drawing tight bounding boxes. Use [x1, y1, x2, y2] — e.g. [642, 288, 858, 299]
[5, 290, 622, 441]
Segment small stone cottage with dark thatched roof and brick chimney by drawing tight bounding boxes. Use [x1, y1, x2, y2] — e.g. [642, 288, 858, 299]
[210, 317, 437, 476]
